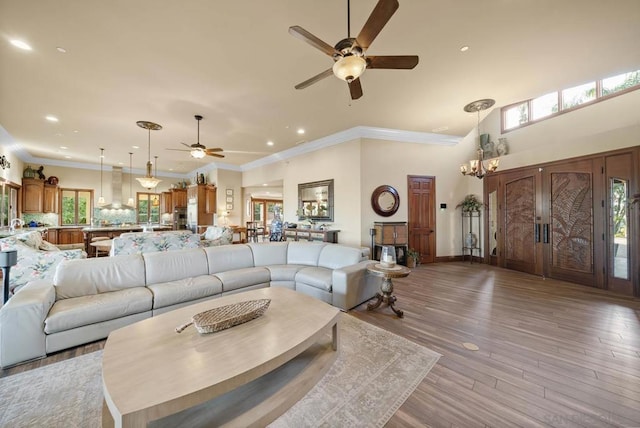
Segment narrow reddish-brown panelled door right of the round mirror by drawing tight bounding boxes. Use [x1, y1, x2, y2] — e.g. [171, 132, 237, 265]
[407, 175, 436, 263]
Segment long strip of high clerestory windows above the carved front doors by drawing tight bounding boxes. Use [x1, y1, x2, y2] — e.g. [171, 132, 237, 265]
[501, 70, 640, 132]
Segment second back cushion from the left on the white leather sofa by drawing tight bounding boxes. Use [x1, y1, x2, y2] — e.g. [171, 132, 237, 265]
[142, 248, 209, 285]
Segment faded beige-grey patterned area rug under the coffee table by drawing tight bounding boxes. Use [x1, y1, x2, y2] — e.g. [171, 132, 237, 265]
[0, 314, 440, 428]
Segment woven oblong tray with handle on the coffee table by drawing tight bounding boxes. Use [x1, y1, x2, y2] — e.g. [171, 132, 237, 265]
[176, 299, 271, 333]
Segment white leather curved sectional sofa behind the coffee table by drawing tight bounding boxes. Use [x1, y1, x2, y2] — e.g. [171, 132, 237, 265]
[0, 242, 380, 367]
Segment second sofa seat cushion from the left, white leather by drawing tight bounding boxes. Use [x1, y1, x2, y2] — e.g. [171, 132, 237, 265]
[147, 275, 222, 309]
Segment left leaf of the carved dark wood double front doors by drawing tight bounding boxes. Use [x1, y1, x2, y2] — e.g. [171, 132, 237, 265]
[498, 168, 543, 275]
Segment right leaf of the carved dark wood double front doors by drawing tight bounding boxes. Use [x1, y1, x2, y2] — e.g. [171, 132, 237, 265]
[542, 159, 604, 287]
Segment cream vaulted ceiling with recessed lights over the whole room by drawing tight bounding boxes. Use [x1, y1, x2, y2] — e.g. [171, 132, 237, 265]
[0, 0, 640, 173]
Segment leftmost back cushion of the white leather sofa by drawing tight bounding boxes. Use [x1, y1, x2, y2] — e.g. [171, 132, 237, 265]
[53, 255, 145, 300]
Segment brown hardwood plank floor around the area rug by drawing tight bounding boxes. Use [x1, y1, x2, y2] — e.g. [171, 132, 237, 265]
[0, 263, 640, 427]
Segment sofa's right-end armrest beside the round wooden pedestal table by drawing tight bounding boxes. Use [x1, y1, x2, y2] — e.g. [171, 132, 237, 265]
[332, 260, 380, 311]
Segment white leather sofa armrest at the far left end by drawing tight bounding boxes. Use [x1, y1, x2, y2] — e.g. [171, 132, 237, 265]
[0, 280, 56, 367]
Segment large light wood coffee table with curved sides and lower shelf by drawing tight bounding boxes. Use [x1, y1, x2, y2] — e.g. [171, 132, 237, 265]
[102, 287, 340, 427]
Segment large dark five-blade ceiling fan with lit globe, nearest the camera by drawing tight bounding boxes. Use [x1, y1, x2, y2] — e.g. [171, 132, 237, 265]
[289, 0, 418, 100]
